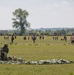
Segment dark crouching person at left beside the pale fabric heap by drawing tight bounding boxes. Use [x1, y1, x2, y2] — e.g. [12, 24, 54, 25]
[1, 44, 9, 60]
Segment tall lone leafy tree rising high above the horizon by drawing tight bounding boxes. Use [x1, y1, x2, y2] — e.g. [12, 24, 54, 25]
[12, 8, 30, 35]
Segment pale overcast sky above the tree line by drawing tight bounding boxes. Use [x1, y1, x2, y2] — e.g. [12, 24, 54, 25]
[0, 0, 74, 29]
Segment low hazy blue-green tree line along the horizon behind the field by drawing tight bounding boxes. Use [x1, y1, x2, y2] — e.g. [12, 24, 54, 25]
[0, 28, 74, 36]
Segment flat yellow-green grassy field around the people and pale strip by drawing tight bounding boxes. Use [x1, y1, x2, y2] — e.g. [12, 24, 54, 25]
[0, 36, 74, 75]
